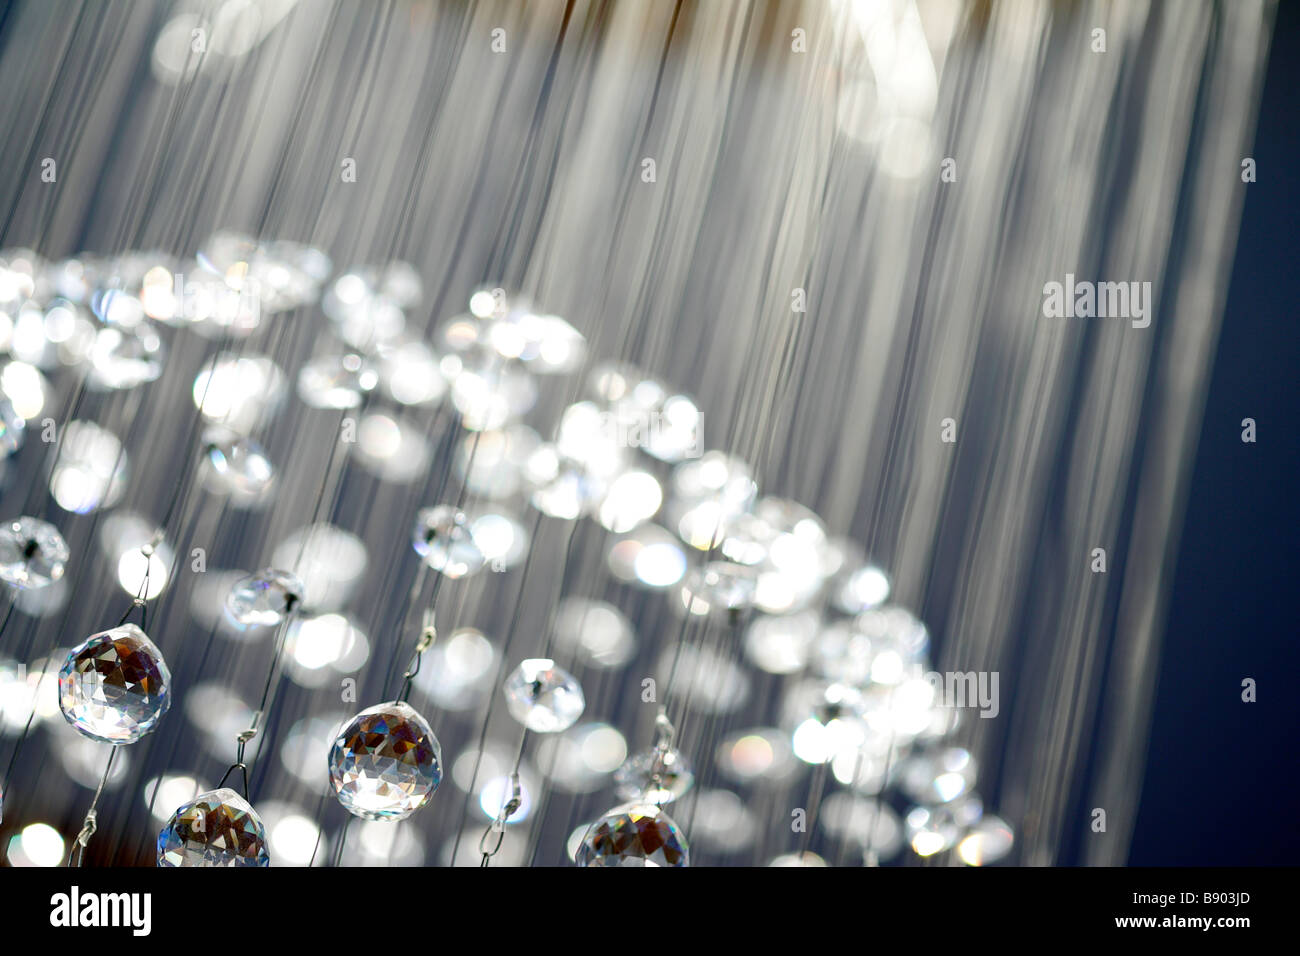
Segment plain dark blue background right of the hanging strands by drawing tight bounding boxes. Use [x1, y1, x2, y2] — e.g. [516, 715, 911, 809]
[1130, 0, 1300, 866]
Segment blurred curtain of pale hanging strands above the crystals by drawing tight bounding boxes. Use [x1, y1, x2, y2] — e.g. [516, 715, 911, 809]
[0, 0, 1273, 864]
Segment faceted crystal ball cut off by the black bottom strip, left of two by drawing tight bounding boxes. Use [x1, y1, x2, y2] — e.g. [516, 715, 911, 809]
[157, 787, 270, 866]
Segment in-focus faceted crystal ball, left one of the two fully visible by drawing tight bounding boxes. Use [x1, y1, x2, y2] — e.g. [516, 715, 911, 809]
[59, 624, 172, 744]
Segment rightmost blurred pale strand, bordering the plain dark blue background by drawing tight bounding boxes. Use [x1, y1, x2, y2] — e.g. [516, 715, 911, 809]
[1082, 0, 1275, 866]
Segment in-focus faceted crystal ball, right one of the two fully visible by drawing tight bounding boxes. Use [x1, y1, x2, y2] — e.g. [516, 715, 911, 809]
[329, 701, 442, 819]
